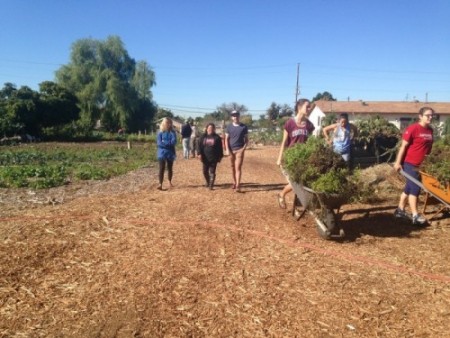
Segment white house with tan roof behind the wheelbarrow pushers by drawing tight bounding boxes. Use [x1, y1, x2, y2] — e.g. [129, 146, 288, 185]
[309, 100, 450, 134]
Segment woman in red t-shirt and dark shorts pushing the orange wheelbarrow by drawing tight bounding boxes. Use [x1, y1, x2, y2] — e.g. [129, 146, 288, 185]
[394, 107, 434, 225]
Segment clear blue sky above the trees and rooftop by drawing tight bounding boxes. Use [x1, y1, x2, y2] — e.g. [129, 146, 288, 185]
[0, 0, 450, 118]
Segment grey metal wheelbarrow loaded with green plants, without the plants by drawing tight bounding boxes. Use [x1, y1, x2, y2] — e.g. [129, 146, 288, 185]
[288, 178, 348, 239]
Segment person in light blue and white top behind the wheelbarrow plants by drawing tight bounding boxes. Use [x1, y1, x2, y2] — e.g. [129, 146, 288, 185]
[322, 113, 358, 169]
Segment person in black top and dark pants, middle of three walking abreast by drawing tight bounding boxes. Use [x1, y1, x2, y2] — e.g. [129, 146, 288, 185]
[198, 123, 223, 190]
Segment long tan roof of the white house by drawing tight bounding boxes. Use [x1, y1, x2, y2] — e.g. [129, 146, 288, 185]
[314, 100, 450, 115]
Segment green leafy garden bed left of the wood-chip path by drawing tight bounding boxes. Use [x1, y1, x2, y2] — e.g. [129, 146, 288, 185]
[0, 142, 156, 189]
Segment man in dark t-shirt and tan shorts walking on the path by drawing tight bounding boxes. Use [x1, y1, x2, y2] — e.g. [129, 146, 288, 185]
[225, 110, 248, 192]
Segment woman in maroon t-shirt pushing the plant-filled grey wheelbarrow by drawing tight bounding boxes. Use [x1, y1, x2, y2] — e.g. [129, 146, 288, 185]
[277, 99, 315, 209]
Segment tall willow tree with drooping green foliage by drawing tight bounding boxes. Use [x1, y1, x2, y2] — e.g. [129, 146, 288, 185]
[56, 36, 155, 131]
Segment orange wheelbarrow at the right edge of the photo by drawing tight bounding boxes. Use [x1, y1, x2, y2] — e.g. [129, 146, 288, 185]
[400, 170, 450, 221]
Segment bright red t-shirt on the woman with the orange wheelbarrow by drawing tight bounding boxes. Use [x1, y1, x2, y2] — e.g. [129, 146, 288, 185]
[403, 123, 433, 166]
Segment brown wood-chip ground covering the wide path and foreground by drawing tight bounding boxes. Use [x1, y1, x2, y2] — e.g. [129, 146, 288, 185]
[0, 146, 450, 337]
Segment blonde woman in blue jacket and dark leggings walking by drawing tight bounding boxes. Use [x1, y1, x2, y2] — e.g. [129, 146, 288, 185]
[156, 117, 177, 190]
